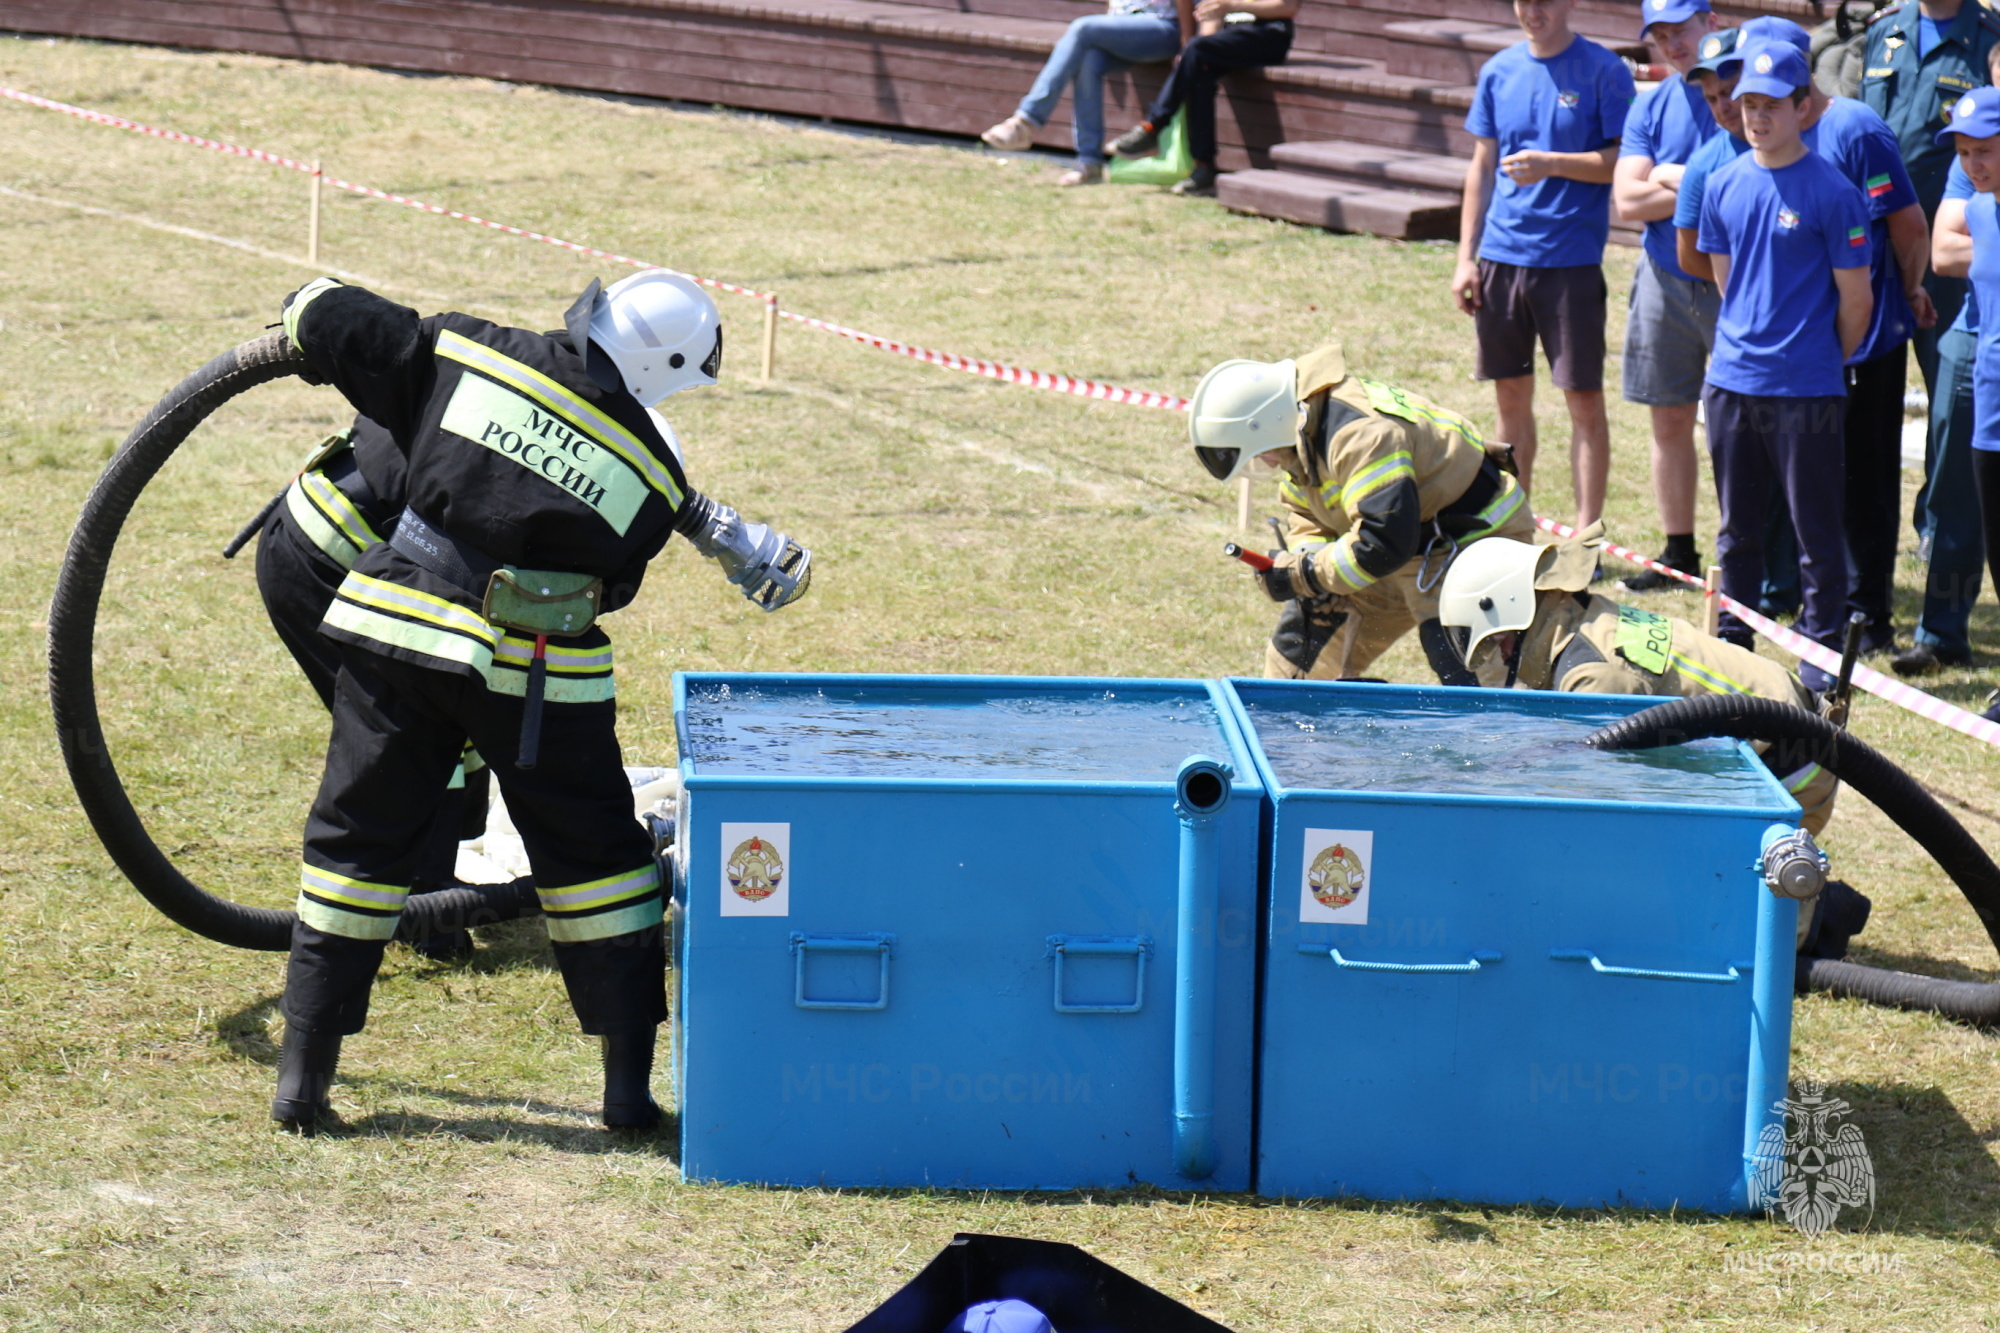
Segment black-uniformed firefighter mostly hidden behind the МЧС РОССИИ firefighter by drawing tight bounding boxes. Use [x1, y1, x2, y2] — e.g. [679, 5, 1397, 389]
[256, 416, 490, 959]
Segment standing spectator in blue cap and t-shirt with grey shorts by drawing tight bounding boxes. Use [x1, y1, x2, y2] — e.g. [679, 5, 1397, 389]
[1612, 0, 1736, 592]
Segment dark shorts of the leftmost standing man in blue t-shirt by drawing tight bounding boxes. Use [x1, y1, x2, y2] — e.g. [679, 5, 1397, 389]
[1472, 260, 1608, 390]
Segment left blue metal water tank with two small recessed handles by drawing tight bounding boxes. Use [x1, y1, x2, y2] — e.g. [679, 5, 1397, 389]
[674, 675, 1262, 1191]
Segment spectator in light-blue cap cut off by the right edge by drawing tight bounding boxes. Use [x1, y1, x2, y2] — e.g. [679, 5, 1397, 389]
[1890, 156, 2000, 677]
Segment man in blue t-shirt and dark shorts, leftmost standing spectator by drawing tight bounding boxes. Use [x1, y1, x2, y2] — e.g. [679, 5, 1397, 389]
[1452, 0, 1632, 526]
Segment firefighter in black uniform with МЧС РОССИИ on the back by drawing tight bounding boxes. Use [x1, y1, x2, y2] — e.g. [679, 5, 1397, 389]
[272, 270, 810, 1129]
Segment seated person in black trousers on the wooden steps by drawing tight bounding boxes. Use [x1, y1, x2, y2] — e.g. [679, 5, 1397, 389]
[1112, 0, 1298, 194]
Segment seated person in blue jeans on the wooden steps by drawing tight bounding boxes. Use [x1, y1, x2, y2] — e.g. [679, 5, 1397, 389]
[980, 0, 1194, 186]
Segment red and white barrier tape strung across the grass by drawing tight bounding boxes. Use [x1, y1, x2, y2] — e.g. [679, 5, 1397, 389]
[0, 86, 2000, 745]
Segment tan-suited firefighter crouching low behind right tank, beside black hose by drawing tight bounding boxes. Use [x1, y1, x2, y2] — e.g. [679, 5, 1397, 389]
[1438, 522, 1870, 959]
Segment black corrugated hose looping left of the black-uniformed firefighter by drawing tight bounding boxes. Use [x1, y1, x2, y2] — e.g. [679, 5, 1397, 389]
[48, 332, 538, 951]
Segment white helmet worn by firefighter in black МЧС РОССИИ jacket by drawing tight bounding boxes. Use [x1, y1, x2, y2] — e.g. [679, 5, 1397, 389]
[566, 268, 722, 406]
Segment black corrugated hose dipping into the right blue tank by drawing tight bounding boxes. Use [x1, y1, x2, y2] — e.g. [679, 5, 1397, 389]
[1590, 695, 2000, 1027]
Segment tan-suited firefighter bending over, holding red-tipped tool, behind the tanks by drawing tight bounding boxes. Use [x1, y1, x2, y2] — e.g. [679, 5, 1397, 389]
[1188, 344, 1534, 681]
